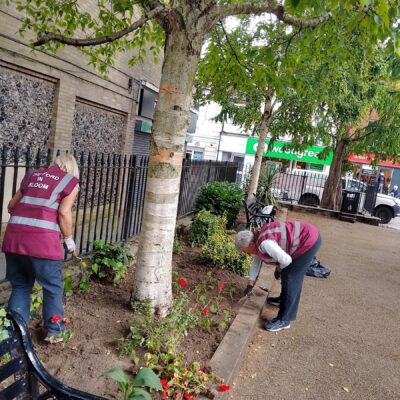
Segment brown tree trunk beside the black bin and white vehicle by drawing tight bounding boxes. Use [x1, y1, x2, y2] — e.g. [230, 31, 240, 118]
[321, 139, 348, 210]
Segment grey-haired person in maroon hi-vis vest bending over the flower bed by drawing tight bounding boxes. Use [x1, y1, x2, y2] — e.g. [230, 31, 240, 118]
[235, 221, 321, 332]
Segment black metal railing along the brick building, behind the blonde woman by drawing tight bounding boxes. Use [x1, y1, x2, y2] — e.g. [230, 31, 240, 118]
[0, 146, 237, 253]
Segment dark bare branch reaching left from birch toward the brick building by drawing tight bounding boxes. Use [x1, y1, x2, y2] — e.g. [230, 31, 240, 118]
[33, 5, 165, 47]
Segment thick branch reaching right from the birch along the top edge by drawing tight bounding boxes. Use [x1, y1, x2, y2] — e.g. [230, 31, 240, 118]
[214, 0, 331, 28]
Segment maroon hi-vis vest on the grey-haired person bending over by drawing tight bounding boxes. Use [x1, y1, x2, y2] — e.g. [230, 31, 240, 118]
[254, 221, 319, 262]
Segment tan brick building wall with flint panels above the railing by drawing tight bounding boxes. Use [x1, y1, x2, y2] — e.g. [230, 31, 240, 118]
[0, 0, 161, 153]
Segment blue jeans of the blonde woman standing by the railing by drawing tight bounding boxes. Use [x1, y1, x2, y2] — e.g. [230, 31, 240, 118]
[6, 253, 64, 335]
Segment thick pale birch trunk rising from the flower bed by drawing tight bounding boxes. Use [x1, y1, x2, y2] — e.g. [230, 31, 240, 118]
[133, 27, 201, 316]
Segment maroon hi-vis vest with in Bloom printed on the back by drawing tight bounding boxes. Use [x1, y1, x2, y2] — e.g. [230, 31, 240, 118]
[2, 165, 79, 260]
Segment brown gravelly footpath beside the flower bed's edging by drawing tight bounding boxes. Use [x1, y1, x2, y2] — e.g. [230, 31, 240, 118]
[228, 212, 400, 400]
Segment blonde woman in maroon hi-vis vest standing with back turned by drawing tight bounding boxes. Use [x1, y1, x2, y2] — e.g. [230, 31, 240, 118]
[2, 154, 79, 343]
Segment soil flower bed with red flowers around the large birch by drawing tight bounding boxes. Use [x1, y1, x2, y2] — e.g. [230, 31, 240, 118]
[32, 246, 246, 399]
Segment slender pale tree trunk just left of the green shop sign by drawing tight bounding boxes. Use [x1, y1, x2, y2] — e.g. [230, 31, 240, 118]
[247, 92, 272, 200]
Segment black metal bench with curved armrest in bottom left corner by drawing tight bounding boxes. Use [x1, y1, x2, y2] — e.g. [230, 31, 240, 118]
[0, 312, 106, 400]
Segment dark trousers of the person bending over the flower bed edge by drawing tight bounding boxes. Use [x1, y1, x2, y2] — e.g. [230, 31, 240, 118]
[277, 236, 321, 321]
